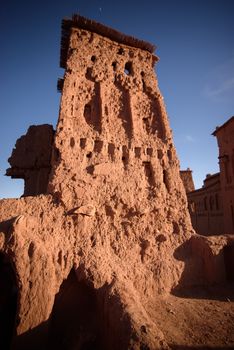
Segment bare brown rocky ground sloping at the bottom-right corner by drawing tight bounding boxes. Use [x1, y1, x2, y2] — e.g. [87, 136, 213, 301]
[147, 284, 234, 350]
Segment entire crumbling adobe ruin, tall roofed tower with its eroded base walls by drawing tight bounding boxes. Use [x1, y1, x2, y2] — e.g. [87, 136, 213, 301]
[0, 15, 234, 350]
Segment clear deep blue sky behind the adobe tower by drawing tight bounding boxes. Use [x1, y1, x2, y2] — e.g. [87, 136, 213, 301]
[0, 0, 234, 198]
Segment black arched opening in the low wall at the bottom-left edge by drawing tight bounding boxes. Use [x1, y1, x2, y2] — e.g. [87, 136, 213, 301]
[0, 253, 18, 350]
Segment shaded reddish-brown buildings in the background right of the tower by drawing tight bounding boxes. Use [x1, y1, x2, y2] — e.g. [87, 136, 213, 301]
[186, 116, 234, 235]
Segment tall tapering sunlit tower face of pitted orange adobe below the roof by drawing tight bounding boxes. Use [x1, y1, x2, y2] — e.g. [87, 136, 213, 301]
[48, 28, 192, 297]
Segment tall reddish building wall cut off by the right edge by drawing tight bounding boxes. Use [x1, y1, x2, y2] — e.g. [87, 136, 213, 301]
[213, 117, 234, 234]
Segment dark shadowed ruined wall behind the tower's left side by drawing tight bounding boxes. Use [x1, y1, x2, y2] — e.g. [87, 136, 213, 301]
[6, 124, 54, 196]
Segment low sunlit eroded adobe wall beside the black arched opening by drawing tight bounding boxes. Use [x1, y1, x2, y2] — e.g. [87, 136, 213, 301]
[0, 195, 74, 334]
